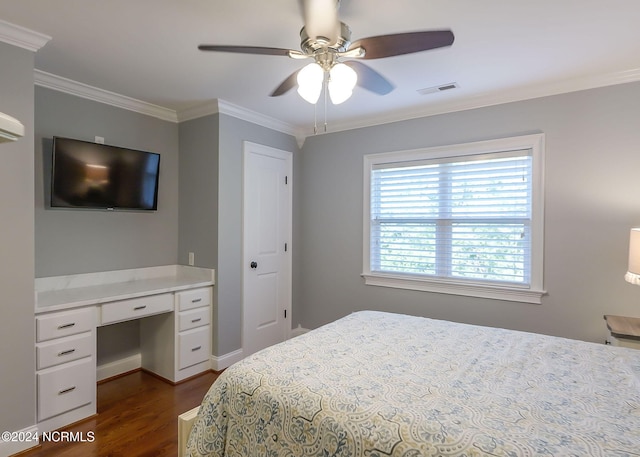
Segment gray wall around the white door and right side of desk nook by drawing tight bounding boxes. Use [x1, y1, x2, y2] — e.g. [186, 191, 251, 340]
[178, 114, 298, 356]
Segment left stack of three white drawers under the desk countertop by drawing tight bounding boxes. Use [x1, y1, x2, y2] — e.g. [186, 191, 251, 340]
[36, 306, 96, 432]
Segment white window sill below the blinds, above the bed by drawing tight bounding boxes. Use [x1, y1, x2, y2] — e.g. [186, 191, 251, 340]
[362, 273, 546, 305]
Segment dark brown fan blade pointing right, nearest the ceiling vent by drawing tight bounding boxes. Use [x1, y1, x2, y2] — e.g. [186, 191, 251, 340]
[349, 30, 454, 59]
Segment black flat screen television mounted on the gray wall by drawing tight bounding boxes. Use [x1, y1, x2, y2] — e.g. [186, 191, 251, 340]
[51, 137, 160, 210]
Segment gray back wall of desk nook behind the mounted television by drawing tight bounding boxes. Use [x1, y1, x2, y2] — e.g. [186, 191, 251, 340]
[35, 87, 178, 277]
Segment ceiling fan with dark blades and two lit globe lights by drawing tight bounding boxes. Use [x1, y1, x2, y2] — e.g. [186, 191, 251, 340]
[198, 0, 454, 104]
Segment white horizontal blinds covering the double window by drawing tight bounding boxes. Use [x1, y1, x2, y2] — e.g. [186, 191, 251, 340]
[369, 149, 533, 286]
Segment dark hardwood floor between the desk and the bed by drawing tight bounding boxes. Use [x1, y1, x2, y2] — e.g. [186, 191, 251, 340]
[19, 371, 218, 457]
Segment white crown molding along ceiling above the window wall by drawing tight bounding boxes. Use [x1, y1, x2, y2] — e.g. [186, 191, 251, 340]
[304, 68, 640, 136]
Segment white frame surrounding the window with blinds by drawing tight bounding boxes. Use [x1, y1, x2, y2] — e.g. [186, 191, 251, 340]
[362, 133, 546, 304]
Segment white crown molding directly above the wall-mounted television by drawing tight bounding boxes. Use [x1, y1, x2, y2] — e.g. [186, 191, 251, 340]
[34, 70, 178, 122]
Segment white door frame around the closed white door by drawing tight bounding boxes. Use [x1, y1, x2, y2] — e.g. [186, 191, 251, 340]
[241, 141, 293, 357]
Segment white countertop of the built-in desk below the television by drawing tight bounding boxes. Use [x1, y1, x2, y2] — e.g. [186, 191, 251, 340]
[35, 265, 215, 314]
